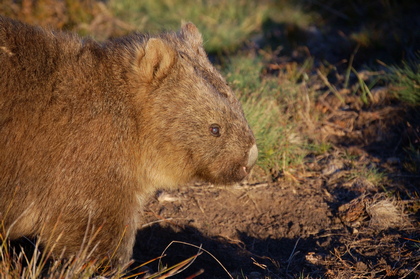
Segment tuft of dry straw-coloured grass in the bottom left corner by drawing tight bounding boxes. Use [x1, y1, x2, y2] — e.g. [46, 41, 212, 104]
[0, 223, 129, 279]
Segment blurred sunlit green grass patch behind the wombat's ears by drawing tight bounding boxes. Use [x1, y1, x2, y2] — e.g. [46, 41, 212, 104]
[108, 0, 269, 52]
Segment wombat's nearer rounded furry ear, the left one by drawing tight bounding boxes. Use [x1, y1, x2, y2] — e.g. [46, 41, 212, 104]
[136, 38, 177, 82]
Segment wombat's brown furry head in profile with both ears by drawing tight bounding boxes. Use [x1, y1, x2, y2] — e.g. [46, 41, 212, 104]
[130, 23, 258, 187]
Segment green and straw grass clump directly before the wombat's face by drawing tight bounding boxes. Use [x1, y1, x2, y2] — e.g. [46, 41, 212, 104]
[224, 54, 328, 177]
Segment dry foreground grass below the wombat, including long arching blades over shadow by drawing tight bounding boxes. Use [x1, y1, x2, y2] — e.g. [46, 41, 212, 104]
[0, 235, 203, 279]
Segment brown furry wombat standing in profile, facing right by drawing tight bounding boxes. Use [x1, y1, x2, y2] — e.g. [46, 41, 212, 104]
[0, 16, 258, 264]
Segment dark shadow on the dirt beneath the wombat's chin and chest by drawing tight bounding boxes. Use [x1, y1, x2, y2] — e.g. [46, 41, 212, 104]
[134, 225, 326, 278]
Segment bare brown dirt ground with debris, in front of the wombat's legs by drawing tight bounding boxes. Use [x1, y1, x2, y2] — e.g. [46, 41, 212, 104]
[135, 98, 420, 278]
